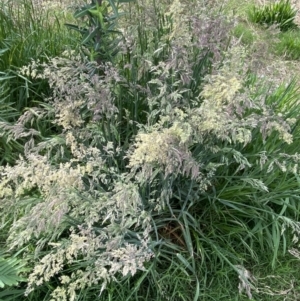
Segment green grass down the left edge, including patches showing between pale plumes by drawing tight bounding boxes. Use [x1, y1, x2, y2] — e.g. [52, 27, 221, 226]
[0, 0, 78, 163]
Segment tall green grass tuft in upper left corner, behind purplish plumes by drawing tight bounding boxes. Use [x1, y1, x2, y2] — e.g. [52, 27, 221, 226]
[0, 0, 77, 112]
